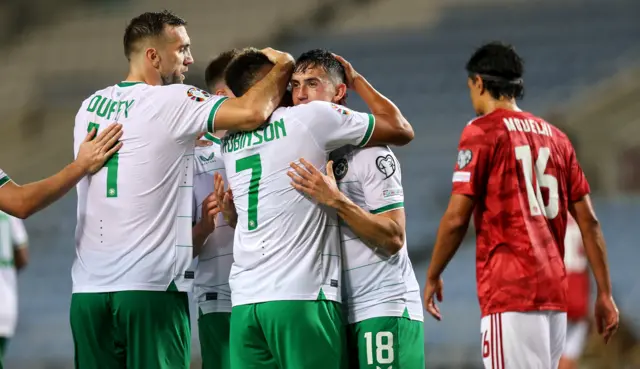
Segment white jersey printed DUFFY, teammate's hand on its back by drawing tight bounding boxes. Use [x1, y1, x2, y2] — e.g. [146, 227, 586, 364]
[72, 82, 225, 292]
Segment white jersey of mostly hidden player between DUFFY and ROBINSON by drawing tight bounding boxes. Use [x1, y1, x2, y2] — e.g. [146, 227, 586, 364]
[193, 133, 234, 314]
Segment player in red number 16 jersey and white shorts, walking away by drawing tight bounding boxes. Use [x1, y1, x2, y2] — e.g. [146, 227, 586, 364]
[424, 43, 618, 369]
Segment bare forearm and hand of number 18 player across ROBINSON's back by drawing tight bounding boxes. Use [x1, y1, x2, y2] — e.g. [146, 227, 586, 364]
[288, 159, 405, 255]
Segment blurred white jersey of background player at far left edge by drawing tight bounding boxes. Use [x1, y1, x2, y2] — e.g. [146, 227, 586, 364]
[0, 211, 28, 337]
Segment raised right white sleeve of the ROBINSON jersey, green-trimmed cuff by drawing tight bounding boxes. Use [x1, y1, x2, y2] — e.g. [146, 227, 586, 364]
[299, 101, 375, 152]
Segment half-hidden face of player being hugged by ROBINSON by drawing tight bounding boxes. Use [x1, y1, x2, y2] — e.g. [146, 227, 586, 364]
[291, 68, 346, 105]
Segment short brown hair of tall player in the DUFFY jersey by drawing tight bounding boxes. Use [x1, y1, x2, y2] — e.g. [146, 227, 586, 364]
[123, 10, 187, 60]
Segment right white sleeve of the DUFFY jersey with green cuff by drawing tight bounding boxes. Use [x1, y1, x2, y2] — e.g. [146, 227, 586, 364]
[158, 84, 227, 141]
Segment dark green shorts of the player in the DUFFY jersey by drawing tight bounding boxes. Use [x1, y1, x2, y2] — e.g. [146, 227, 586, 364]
[70, 291, 191, 369]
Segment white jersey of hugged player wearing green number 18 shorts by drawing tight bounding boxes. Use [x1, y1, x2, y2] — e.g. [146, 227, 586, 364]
[331, 146, 423, 324]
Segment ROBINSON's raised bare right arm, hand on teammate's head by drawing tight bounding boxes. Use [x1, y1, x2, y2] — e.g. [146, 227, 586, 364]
[336, 55, 414, 146]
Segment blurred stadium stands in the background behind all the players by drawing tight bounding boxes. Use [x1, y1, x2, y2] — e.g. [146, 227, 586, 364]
[0, 0, 640, 369]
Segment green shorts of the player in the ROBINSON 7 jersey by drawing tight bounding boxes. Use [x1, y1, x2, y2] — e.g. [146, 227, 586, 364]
[230, 301, 348, 369]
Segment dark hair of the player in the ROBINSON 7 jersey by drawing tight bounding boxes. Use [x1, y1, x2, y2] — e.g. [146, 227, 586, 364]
[224, 48, 274, 96]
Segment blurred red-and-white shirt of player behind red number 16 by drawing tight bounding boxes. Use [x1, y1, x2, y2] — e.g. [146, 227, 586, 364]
[564, 215, 591, 321]
